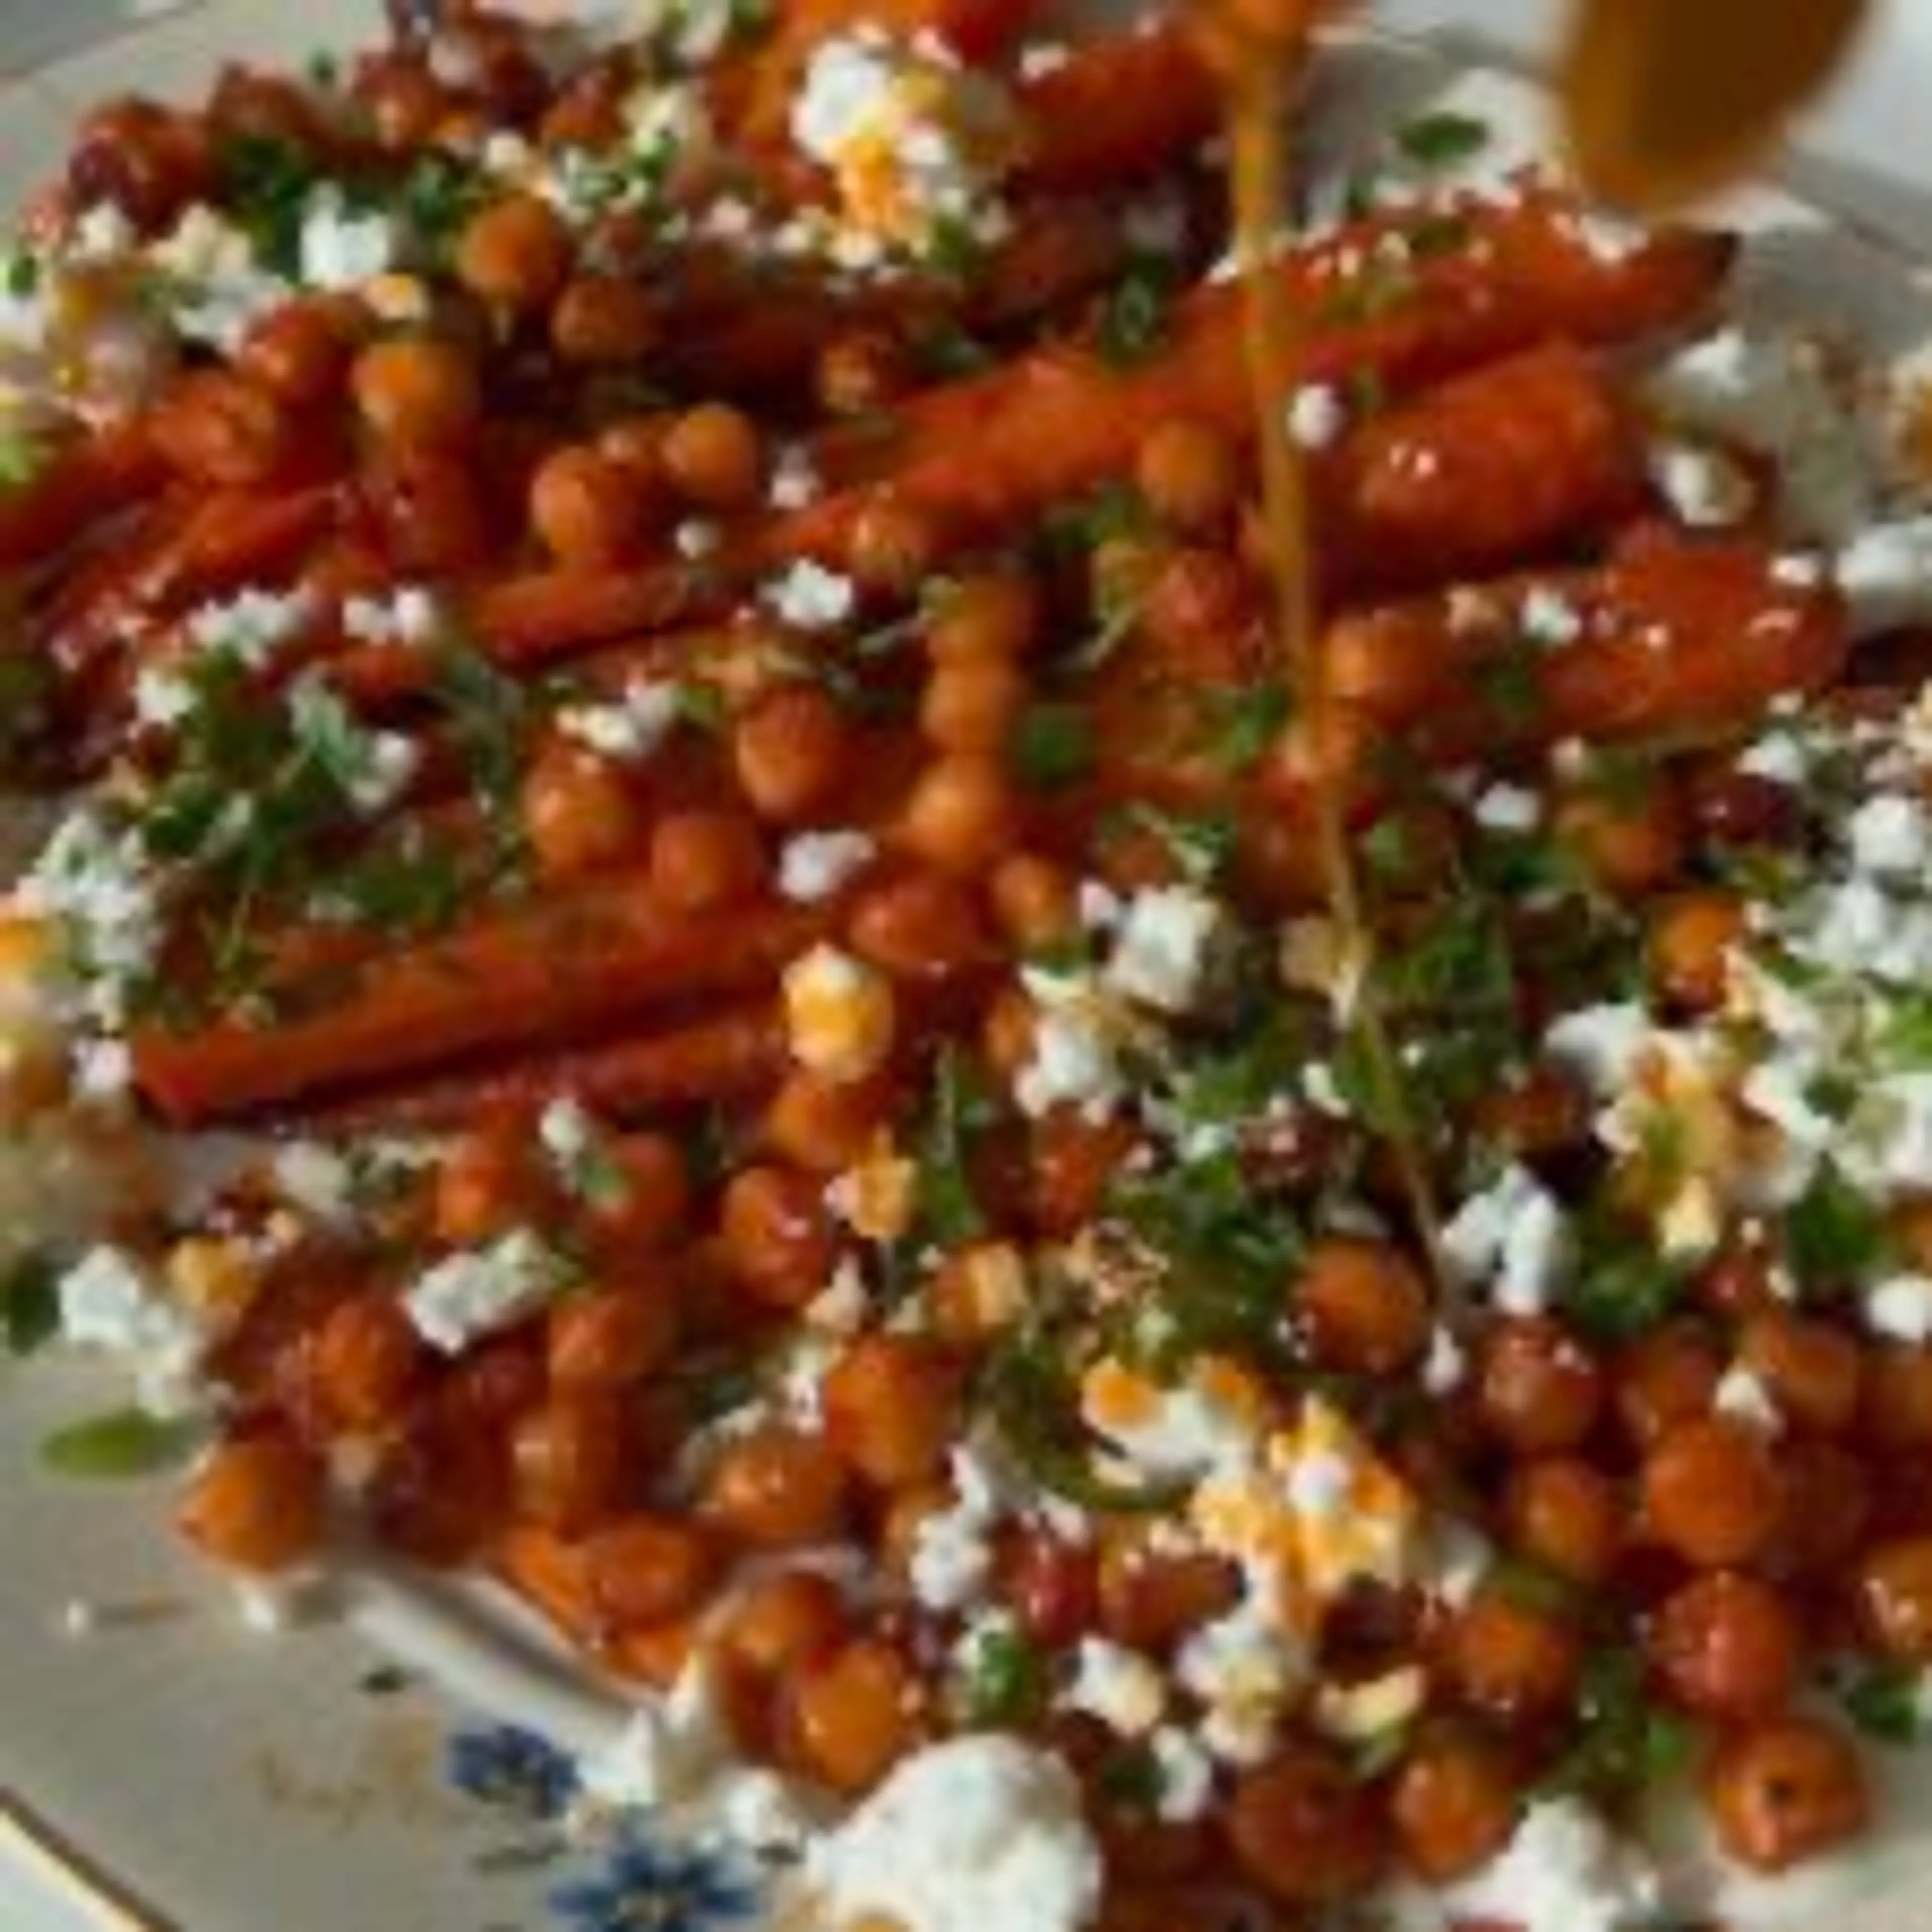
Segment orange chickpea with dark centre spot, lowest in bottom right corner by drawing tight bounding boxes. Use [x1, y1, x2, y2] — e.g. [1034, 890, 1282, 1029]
[1704, 1718, 1872, 1872]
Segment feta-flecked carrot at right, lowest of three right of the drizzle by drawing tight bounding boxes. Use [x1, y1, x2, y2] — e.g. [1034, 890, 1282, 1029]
[1325, 545, 1847, 754]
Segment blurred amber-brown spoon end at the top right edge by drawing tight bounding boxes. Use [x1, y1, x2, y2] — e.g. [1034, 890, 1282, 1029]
[1561, 0, 1874, 214]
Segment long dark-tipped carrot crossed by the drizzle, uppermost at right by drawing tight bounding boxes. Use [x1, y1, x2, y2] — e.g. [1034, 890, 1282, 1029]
[784, 197, 1731, 558]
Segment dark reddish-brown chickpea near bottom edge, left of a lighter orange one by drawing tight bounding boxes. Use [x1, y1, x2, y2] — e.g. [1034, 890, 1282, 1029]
[1227, 1743, 1387, 1905]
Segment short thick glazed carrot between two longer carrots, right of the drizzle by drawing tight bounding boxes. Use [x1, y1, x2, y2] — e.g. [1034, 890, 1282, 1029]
[1316, 344, 1644, 586]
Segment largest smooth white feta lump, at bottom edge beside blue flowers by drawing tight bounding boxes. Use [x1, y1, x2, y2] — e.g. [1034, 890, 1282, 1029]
[806, 1737, 1101, 1932]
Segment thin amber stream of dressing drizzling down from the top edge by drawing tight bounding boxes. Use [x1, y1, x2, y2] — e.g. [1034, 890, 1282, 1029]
[1201, 11, 1447, 1291]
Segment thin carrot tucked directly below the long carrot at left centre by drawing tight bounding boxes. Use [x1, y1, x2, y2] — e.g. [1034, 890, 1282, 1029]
[303, 1001, 784, 1134]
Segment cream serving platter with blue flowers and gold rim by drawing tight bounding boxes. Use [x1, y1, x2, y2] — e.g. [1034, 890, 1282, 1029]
[11, 0, 1932, 1932]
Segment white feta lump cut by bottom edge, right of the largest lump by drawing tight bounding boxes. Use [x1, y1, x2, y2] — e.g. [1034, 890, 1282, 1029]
[1449, 1799, 1663, 1932]
